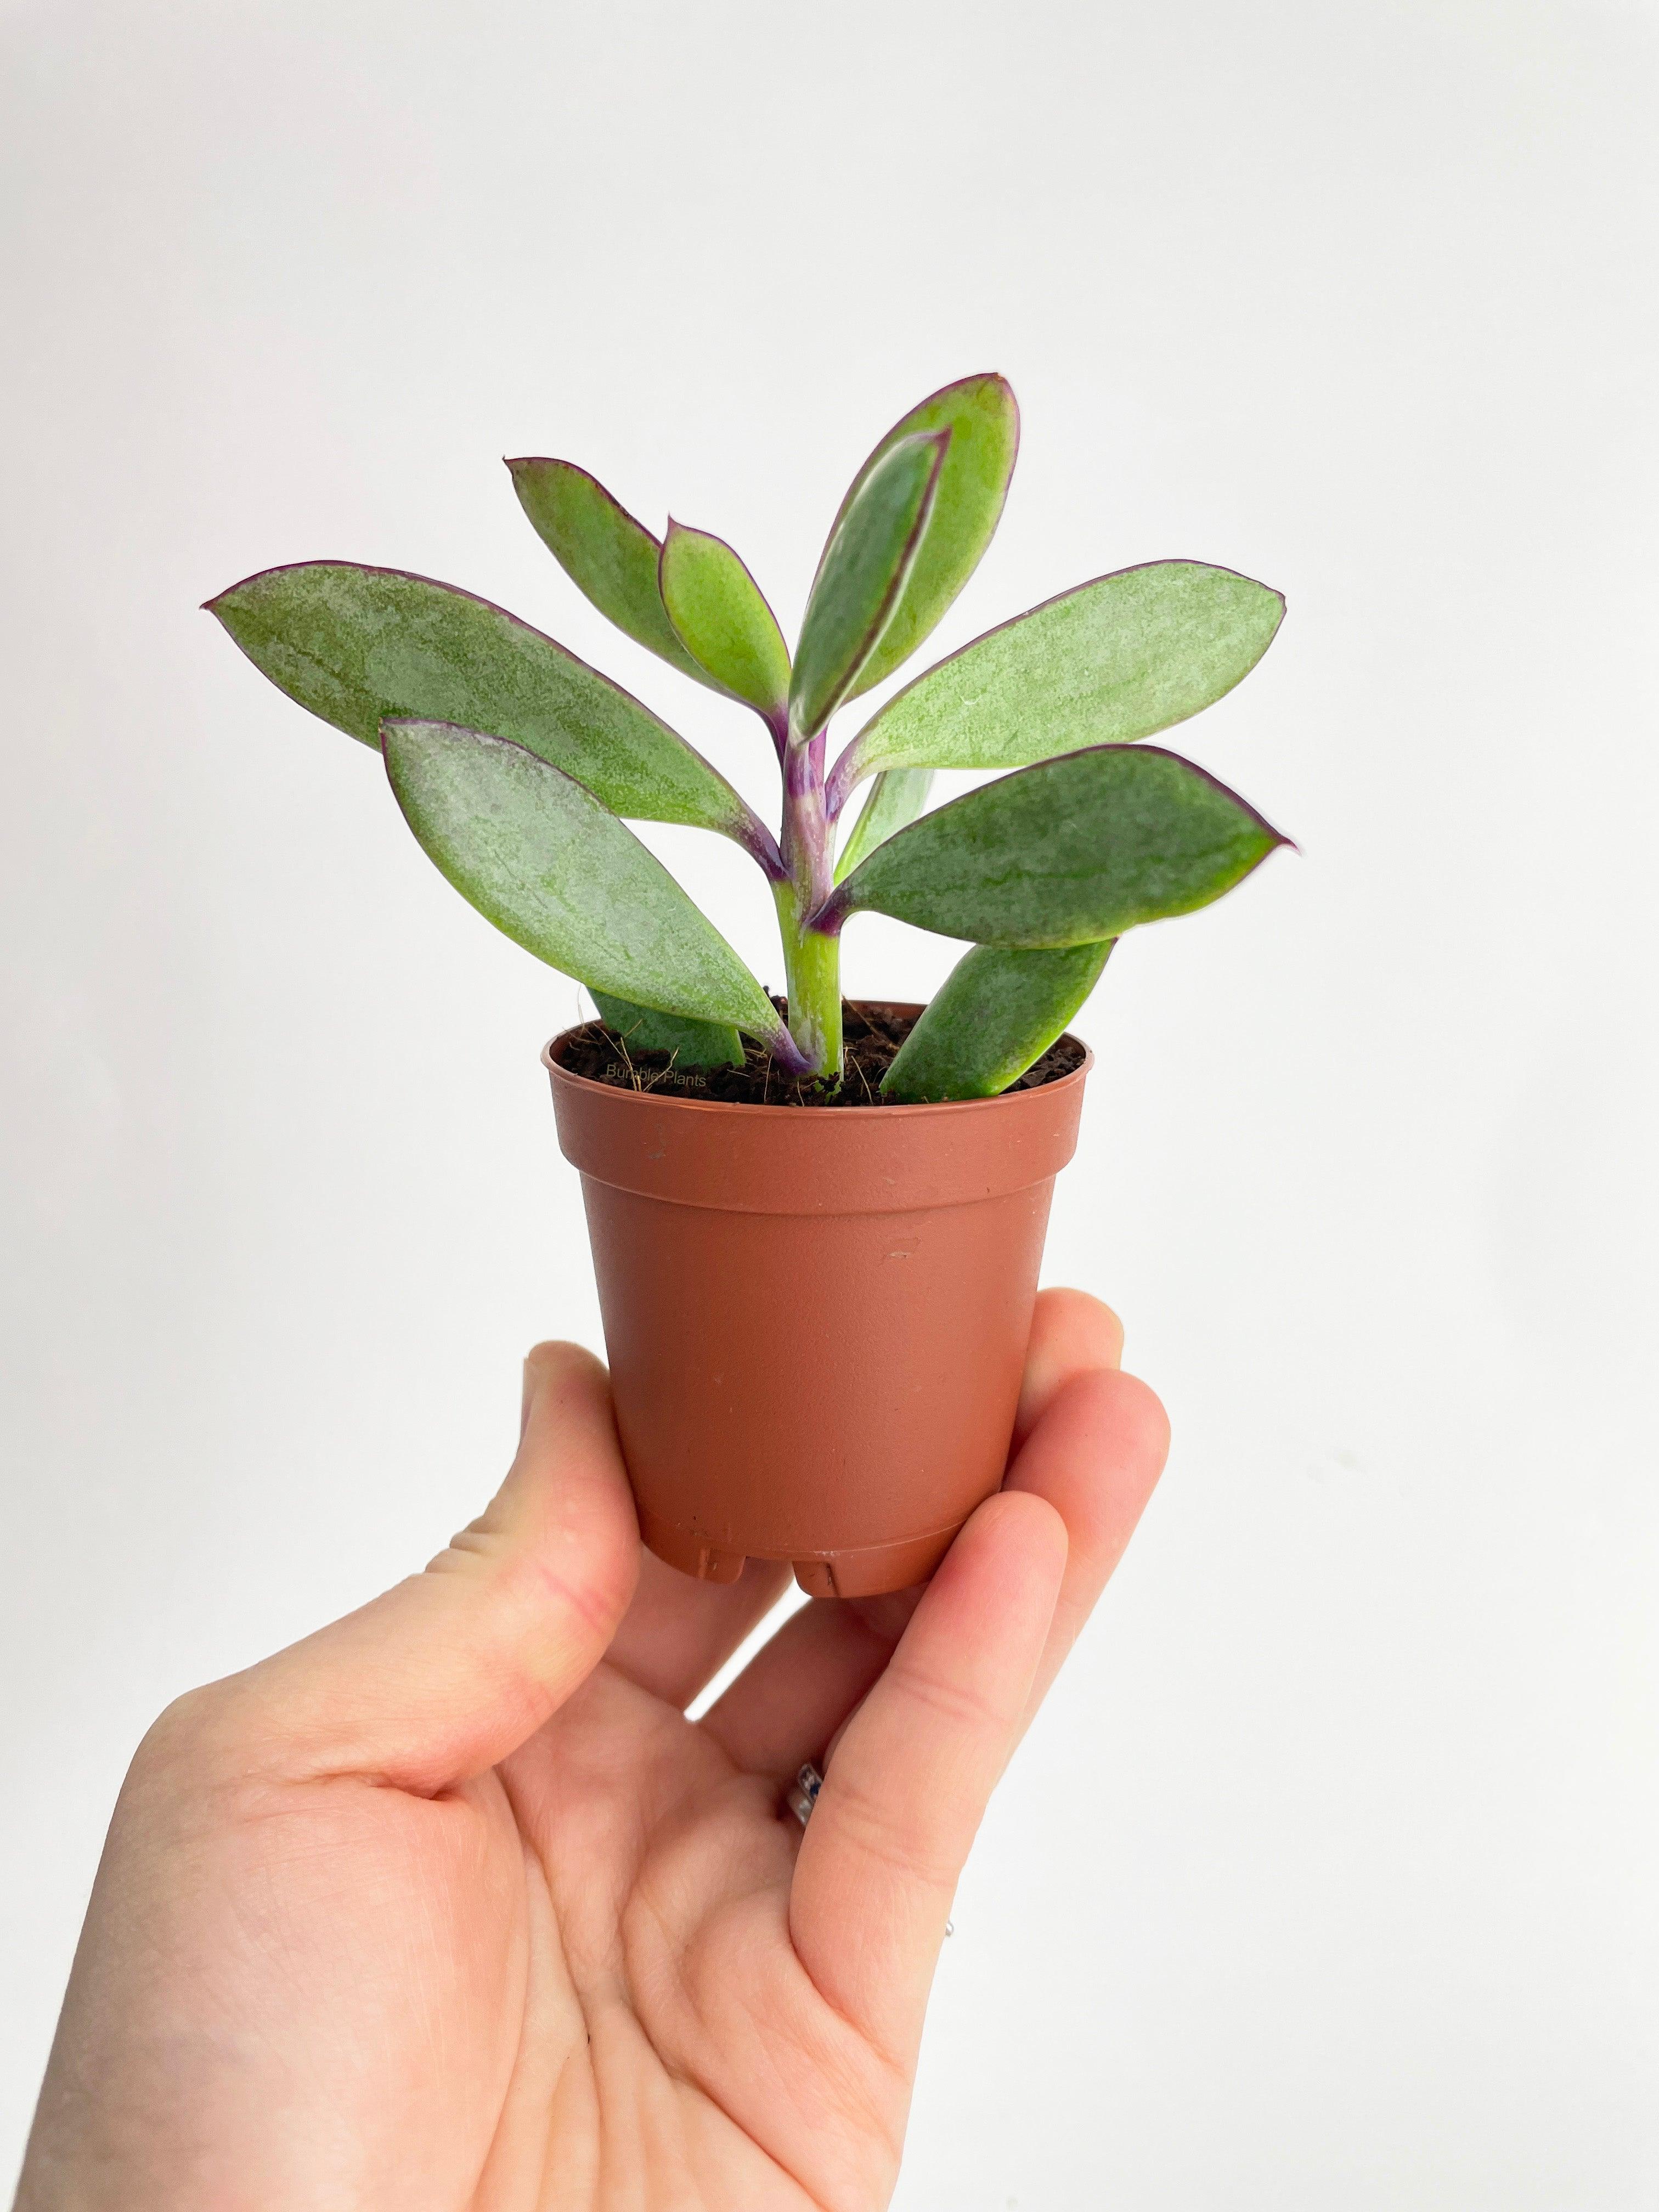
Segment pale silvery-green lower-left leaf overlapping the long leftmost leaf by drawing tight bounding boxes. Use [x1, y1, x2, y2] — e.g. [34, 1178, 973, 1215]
[383, 721, 783, 1042]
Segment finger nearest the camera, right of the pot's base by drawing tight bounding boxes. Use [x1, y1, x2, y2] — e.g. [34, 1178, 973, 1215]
[789, 1491, 1066, 2064]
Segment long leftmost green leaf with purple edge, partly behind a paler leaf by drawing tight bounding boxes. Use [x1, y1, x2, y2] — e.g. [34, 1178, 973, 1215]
[208, 562, 759, 845]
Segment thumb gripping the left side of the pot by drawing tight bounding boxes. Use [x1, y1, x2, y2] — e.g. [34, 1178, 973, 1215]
[219, 1345, 639, 1796]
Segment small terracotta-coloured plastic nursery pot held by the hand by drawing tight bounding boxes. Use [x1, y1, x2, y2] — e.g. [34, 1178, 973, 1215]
[542, 1007, 1093, 1597]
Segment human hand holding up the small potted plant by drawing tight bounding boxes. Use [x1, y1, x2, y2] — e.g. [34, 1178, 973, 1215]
[18, 1292, 1166, 2212]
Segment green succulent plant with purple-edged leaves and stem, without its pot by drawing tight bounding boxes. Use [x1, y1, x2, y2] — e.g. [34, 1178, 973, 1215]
[208, 376, 1285, 1099]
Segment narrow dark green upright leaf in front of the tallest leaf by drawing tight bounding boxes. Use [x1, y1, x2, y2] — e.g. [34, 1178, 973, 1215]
[789, 429, 951, 737]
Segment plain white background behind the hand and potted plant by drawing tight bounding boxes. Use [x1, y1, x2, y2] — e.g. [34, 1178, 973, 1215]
[0, 0, 1659, 2212]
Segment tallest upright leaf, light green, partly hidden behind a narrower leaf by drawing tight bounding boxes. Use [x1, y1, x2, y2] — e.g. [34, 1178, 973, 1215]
[836, 376, 1020, 699]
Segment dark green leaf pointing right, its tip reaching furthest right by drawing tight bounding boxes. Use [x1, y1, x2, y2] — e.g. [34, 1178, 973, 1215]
[825, 746, 1288, 947]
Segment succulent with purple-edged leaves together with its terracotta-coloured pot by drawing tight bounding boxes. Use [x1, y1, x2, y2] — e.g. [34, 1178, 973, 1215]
[208, 376, 1285, 1595]
